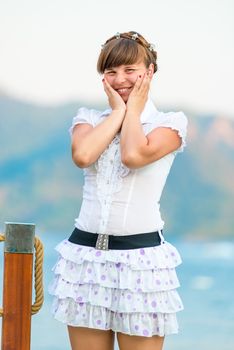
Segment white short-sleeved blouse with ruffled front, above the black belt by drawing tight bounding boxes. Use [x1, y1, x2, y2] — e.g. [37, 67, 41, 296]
[70, 99, 187, 235]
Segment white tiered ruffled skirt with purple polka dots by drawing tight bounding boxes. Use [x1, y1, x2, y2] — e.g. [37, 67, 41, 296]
[49, 240, 183, 337]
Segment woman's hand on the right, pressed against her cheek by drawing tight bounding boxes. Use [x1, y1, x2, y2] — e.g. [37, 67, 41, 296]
[127, 73, 151, 115]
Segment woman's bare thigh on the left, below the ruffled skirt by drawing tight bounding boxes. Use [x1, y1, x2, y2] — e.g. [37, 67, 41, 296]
[68, 326, 114, 350]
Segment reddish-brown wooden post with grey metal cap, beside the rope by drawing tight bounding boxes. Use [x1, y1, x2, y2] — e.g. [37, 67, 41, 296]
[2, 222, 35, 350]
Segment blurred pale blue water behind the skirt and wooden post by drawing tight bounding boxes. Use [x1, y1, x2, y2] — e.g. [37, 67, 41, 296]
[0, 234, 234, 350]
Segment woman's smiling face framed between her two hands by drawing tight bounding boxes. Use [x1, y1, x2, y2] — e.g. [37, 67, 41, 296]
[104, 62, 154, 103]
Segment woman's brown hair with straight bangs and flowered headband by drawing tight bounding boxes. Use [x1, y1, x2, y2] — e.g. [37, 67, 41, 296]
[97, 31, 158, 74]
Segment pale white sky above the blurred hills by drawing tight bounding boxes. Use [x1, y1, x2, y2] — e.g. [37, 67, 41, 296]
[0, 0, 234, 118]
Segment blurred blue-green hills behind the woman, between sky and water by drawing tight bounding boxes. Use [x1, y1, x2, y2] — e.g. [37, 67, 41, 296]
[0, 95, 234, 239]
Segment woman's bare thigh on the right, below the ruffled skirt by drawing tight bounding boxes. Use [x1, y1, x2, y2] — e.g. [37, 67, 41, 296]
[117, 333, 164, 350]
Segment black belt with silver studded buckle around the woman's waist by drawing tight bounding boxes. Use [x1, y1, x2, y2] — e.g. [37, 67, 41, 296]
[68, 228, 164, 250]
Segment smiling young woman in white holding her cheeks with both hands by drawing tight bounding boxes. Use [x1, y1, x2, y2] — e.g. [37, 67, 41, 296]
[51, 32, 187, 350]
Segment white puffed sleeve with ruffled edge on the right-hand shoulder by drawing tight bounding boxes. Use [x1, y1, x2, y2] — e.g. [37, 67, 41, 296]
[160, 112, 188, 154]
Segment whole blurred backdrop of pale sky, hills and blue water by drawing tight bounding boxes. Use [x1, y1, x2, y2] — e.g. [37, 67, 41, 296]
[0, 0, 234, 350]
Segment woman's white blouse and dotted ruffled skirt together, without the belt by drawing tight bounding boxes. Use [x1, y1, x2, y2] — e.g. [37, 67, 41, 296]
[50, 99, 187, 337]
